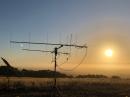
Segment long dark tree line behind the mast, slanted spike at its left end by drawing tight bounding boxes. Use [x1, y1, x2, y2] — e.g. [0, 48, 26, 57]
[0, 57, 69, 78]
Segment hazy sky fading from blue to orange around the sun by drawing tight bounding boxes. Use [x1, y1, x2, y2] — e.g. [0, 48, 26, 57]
[0, 0, 130, 76]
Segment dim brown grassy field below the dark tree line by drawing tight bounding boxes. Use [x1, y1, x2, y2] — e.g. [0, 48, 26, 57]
[0, 77, 130, 97]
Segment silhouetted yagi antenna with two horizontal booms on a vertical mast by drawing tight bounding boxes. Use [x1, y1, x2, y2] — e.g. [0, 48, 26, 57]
[10, 39, 87, 97]
